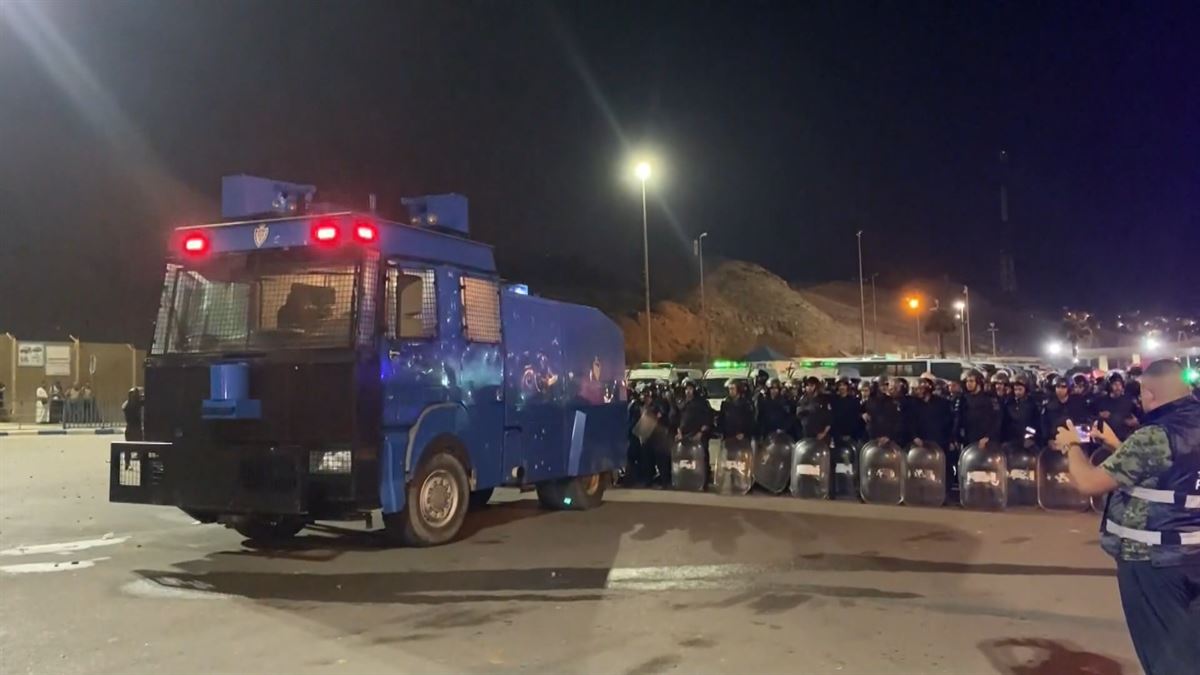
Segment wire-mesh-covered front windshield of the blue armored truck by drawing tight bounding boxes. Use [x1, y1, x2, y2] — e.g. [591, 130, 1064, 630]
[154, 250, 359, 353]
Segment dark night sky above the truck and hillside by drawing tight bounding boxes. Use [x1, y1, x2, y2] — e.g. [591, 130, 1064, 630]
[0, 0, 1200, 344]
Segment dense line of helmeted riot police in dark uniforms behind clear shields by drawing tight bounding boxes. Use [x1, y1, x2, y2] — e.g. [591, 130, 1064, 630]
[626, 366, 1180, 486]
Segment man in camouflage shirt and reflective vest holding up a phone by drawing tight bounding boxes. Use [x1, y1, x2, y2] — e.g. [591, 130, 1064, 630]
[1054, 360, 1200, 675]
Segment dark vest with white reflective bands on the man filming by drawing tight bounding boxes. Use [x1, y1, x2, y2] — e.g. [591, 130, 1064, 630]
[1102, 396, 1200, 557]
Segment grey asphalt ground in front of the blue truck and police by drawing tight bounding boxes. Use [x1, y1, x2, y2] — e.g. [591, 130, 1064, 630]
[0, 436, 1140, 675]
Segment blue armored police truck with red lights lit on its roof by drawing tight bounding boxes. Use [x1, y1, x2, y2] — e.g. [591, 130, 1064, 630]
[109, 175, 626, 545]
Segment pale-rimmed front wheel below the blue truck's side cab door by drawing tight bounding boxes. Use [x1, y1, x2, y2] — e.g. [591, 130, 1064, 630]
[384, 452, 469, 546]
